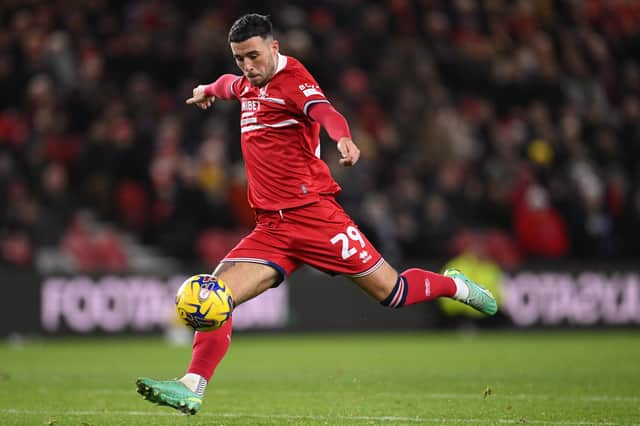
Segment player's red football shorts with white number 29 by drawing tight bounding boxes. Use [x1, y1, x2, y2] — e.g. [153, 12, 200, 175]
[222, 197, 383, 279]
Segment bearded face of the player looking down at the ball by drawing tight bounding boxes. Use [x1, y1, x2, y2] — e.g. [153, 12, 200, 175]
[230, 36, 278, 87]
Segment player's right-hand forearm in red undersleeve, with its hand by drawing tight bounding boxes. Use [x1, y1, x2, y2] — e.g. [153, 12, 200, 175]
[309, 102, 360, 167]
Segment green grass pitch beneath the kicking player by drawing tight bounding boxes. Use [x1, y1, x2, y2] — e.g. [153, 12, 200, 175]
[0, 330, 640, 425]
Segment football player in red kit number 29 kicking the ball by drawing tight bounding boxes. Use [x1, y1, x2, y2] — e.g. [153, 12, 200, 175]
[136, 14, 497, 414]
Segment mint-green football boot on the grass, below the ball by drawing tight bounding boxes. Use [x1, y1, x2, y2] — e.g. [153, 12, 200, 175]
[136, 377, 202, 414]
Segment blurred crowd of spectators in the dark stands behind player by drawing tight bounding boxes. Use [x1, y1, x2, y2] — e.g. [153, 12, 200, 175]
[0, 0, 640, 270]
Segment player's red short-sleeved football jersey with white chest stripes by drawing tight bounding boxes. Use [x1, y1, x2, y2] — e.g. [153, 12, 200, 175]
[231, 55, 340, 210]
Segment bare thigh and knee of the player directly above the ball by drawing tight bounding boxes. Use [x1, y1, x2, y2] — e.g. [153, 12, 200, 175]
[213, 262, 280, 306]
